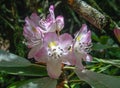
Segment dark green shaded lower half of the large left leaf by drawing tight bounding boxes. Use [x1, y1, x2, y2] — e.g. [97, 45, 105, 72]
[0, 65, 47, 76]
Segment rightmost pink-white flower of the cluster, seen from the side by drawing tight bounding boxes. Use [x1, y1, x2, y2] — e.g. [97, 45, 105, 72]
[73, 24, 92, 70]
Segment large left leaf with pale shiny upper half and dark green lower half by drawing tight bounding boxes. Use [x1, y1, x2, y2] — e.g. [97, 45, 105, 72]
[0, 50, 47, 76]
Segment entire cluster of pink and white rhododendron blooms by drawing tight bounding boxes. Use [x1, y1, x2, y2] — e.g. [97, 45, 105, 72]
[23, 5, 92, 79]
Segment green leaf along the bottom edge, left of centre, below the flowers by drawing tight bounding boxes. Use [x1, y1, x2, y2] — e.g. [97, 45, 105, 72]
[8, 77, 57, 88]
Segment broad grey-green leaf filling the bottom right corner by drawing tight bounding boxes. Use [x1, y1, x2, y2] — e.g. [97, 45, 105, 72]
[75, 69, 120, 88]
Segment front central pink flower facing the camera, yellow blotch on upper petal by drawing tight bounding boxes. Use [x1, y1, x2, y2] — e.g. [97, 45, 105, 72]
[34, 32, 74, 79]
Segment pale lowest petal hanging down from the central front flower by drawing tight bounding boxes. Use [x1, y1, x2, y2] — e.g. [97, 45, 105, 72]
[47, 59, 62, 79]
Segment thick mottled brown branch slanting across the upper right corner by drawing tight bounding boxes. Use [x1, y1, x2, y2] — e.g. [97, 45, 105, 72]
[67, 0, 120, 46]
